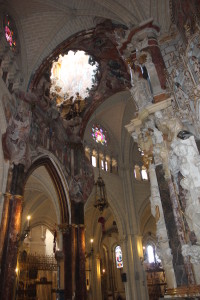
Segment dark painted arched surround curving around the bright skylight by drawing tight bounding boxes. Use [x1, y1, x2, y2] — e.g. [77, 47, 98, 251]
[27, 20, 130, 137]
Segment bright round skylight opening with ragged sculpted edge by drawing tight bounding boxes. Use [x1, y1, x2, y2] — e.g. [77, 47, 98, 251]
[50, 50, 99, 106]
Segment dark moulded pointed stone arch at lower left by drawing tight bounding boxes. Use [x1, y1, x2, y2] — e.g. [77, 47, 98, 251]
[24, 155, 71, 224]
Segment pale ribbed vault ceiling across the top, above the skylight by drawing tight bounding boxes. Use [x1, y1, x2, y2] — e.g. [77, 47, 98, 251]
[0, 0, 170, 81]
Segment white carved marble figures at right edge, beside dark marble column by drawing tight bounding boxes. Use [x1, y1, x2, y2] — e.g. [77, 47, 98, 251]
[170, 136, 200, 241]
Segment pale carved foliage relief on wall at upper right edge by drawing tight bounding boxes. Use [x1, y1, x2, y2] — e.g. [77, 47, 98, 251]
[167, 27, 200, 137]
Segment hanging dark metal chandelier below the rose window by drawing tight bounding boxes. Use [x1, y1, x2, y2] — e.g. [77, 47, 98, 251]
[94, 173, 108, 213]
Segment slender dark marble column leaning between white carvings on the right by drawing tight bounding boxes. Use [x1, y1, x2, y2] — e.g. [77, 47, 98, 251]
[156, 165, 189, 287]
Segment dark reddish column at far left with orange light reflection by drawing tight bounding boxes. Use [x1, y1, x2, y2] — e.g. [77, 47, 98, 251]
[0, 164, 24, 300]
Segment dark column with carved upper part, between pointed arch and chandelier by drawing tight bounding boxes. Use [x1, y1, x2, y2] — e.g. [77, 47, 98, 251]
[69, 143, 94, 300]
